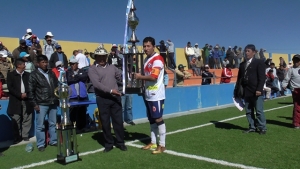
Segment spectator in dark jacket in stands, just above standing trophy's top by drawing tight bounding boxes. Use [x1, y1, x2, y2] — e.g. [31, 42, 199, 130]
[49, 45, 68, 69]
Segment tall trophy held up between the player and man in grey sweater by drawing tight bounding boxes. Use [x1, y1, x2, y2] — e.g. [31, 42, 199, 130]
[123, 0, 144, 94]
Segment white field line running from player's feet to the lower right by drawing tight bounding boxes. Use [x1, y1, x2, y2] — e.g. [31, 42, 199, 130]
[127, 143, 262, 169]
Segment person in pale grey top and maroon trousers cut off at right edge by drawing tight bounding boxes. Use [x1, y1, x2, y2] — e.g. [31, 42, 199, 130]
[282, 54, 300, 129]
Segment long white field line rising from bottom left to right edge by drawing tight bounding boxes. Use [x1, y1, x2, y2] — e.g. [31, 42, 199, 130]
[13, 105, 293, 169]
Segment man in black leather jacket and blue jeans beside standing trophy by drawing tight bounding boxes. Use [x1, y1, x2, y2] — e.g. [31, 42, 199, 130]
[29, 55, 58, 151]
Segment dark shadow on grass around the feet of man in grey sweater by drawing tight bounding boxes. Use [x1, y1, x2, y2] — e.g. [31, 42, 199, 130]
[92, 130, 150, 147]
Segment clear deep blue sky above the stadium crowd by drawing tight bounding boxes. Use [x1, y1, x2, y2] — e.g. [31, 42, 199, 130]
[0, 0, 300, 53]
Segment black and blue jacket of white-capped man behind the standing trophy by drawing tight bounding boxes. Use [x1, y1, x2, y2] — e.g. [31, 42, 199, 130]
[66, 69, 88, 99]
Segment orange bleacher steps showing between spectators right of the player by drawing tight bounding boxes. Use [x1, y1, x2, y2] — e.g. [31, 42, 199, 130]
[167, 69, 239, 87]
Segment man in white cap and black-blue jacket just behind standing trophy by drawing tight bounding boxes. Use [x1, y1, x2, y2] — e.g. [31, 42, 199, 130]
[66, 59, 88, 130]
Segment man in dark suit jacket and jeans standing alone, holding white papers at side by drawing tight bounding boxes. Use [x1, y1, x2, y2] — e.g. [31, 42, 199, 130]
[234, 44, 267, 134]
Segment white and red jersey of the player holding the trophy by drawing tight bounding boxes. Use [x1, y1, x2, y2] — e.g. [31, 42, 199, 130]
[144, 53, 165, 101]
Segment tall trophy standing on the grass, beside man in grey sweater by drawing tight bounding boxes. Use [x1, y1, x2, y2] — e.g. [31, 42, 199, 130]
[54, 69, 79, 164]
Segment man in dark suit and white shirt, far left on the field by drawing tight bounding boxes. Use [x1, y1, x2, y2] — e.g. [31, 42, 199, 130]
[7, 58, 33, 143]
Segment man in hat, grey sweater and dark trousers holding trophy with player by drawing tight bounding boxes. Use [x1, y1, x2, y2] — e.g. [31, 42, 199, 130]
[88, 46, 127, 153]
